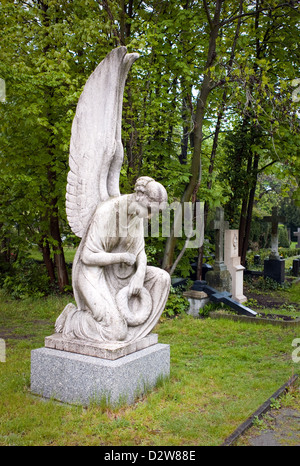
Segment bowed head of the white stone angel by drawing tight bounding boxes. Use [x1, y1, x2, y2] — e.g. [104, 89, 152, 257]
[134, 176, 168, 218]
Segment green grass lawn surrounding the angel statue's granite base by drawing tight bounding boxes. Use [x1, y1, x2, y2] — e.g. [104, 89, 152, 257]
[0, 282, 300, 446]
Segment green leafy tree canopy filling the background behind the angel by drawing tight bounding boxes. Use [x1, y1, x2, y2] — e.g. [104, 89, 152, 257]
[0, 0, 300, 292]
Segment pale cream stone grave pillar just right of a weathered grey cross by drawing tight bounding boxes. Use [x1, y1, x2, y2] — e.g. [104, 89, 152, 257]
[224, 230, 247, 303]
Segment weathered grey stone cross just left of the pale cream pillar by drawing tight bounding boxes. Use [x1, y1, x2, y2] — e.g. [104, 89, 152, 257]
[205, 207, 231, 292]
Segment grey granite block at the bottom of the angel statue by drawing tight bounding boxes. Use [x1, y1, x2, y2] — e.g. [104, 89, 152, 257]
[31, 343, 170, 405]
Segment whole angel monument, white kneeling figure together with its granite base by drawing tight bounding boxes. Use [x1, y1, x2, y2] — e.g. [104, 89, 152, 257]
[31, 47, 170, 404]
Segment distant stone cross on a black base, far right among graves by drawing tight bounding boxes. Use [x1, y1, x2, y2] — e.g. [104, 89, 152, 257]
[263, 207, 285, 283]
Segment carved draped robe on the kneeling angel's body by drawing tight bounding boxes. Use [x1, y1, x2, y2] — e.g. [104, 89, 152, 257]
[57, 195, 170, 343]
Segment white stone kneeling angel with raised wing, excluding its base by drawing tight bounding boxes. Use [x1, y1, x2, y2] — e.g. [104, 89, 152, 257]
[55, 47, 170, 343]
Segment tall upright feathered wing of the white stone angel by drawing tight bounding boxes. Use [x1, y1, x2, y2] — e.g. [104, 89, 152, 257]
[66, 47, 138, 238]
